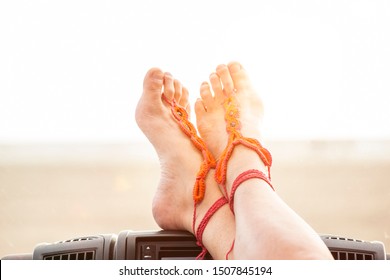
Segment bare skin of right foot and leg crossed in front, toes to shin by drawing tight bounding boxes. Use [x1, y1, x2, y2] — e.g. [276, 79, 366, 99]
[195, 63, 332, 259]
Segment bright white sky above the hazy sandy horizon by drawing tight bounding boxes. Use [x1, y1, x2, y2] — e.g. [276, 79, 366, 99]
[0, 0, 390, 143]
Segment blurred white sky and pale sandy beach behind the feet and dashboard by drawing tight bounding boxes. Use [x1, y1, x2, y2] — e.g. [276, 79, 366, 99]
[0, 0, 390, 257]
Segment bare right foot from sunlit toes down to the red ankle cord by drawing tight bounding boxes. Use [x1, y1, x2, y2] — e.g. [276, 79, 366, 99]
[195, 62, 268, 196]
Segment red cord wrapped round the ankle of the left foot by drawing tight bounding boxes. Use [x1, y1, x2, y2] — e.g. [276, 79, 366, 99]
[192, 196, 228, 260]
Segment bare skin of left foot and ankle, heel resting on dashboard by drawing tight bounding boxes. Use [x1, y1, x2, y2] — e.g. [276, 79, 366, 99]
[135, 68, 235, 259]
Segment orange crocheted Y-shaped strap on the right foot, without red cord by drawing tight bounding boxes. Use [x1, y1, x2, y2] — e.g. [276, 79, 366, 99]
[215, 93, 272, 199]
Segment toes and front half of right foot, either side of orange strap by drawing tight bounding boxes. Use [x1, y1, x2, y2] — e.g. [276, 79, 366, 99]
[195, 62, 263, 158]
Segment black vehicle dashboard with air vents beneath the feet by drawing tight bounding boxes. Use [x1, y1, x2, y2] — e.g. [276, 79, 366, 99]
[2, 230, 390, 260]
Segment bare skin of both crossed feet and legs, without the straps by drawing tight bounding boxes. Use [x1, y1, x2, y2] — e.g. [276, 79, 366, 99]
[136, 62, 332, 259]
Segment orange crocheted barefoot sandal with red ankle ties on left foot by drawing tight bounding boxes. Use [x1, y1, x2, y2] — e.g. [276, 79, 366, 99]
[162, 94, 228, 259]
